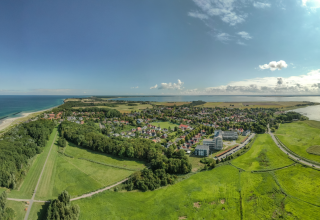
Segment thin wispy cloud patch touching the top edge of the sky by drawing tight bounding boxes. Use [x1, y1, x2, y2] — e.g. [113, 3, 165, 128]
[189, 0, 247, 26]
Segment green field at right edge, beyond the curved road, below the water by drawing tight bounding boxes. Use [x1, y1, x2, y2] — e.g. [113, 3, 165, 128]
[275, 121, 320, 162]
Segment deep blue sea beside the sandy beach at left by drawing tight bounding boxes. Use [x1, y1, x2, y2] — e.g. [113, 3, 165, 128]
[0, 95, 74, 118]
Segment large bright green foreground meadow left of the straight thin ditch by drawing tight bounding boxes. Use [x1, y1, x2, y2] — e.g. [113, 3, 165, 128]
[73, 166, 240, 219]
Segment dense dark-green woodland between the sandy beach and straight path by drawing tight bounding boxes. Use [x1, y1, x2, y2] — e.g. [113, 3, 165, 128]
[0, 120, 55, 189]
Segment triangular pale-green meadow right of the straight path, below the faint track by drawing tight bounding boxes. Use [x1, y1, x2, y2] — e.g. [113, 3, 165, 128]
[36, 140, 135, 200]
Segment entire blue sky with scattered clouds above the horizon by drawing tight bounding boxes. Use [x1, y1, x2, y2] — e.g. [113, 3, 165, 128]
[0, 0, 320, 95]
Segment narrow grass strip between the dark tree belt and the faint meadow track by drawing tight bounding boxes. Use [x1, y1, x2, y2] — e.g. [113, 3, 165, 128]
[65, 142, 146, 170]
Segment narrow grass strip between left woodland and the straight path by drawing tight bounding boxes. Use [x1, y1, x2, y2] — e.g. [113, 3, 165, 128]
[8, 128, 57, 199]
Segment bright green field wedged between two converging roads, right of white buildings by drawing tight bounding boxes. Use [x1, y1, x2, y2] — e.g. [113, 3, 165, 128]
[232, 134, 293, 171]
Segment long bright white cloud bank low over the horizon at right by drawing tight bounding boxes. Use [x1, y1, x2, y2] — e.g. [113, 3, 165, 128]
[182, 69, 320, 95]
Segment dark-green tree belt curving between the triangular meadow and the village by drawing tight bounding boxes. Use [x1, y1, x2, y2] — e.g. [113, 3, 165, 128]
[60, 121, 192, 190]
